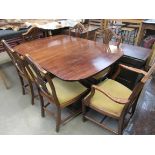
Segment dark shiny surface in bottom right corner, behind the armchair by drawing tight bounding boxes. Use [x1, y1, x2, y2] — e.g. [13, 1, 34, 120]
[124, 75, 155, 135]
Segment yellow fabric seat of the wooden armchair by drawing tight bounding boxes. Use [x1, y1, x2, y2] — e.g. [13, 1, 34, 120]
[90, 79, 132, 117]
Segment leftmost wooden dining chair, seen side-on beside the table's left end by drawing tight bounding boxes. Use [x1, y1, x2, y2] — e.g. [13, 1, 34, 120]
[1, 40, 35, 105]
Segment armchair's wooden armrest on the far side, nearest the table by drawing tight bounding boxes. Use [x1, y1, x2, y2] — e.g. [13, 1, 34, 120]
[112, 64, 147, 80]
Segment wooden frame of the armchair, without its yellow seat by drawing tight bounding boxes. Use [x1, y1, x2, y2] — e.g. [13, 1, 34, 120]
[82, 63, 155, 134]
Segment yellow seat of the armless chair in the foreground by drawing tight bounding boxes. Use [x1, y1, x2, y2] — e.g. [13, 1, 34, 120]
[46, 77, 87, 106]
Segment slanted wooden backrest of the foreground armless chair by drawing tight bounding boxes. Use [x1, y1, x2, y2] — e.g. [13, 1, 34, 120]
[24, 54, 59, 104]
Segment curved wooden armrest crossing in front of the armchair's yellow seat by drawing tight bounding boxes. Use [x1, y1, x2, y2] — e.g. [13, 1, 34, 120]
[92, 85, 130, 104]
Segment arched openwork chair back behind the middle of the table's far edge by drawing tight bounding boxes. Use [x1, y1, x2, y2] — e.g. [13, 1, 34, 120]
[69, 23, 88, 38]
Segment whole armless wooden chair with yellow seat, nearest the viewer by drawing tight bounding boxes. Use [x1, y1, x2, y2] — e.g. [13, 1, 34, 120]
[24, 54, 88, 132]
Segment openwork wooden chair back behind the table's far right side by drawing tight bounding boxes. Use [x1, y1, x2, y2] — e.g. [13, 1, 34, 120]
[94, 28, 122, 48]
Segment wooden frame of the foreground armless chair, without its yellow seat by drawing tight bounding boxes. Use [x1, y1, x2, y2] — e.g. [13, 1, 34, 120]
[24, 54, 88, 132]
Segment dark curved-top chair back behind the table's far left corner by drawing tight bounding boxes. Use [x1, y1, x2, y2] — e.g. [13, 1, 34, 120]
[22, 27, 44, 42]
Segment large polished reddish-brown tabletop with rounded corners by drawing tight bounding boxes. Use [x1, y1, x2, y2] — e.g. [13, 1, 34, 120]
[14, 35, 123, 80]
